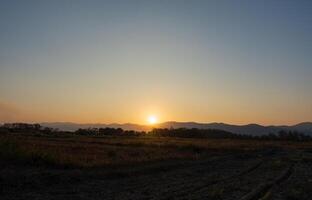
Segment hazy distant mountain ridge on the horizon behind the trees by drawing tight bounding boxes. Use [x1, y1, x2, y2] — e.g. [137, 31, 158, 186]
[41, 121, 312, 136]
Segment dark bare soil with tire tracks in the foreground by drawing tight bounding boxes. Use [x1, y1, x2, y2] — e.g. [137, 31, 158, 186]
[0, 135, 312, 200]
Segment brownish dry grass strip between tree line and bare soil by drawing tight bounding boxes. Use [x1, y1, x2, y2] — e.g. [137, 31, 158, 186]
[0, 135, 311, 167]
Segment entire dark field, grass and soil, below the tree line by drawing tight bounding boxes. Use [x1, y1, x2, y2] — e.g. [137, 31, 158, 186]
[0, 133, 312, 200]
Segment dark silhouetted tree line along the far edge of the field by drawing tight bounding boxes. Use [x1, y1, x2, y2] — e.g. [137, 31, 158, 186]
[0, 123, 312, 141]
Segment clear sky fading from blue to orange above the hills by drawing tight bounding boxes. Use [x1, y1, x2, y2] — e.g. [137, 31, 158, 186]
[0, 0, 312, 125]
